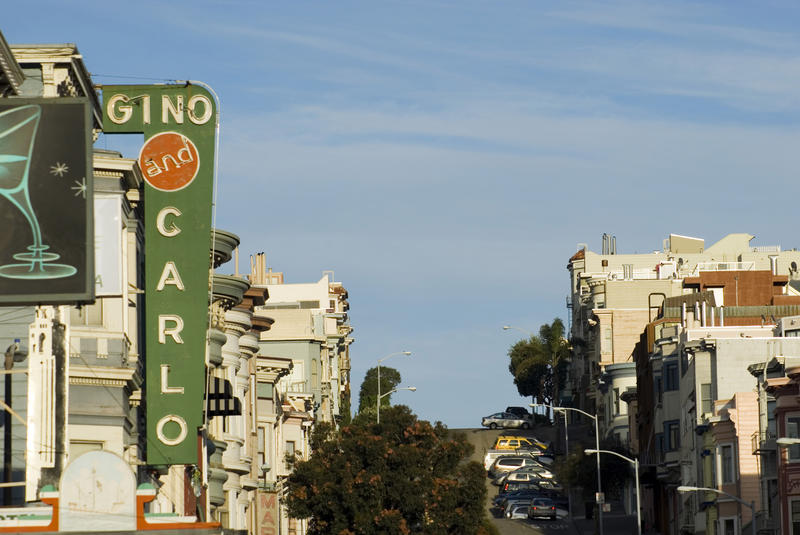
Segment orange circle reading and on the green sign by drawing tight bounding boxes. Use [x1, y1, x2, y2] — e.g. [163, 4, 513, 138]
[139, 132, 200, 191]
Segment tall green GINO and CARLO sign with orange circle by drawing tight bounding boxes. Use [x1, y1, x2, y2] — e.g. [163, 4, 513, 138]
[103, 84, 216, 464]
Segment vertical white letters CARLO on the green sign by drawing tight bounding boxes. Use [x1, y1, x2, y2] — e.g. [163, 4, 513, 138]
[156, 206, 188, 446]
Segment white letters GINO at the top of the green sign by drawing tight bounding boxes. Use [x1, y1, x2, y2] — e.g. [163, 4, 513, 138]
[106, 94, 214, 125]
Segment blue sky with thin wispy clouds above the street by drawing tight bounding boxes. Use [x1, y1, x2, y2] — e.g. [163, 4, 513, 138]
[6, 0, 800, 428]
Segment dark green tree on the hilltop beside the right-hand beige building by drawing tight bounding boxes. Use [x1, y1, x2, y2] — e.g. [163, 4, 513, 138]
[508, 318, 570, 405]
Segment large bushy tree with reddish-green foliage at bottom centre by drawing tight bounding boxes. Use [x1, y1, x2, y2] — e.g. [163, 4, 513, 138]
[286, 406, 494, 535]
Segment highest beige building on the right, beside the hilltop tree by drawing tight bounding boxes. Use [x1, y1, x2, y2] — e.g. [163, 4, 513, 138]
[561, 234, 800, 435]
